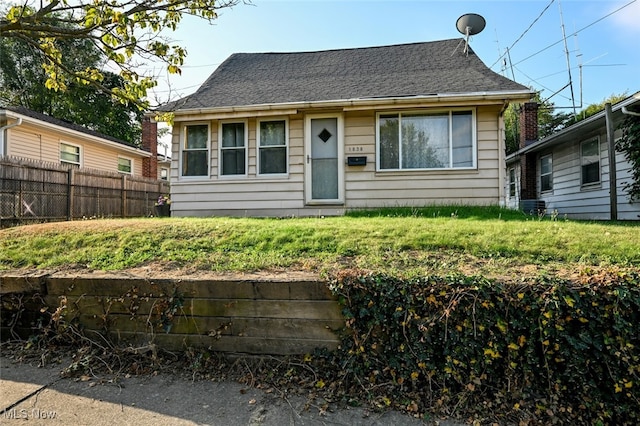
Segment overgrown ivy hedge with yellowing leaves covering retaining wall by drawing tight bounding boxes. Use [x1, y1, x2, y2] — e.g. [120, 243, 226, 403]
[332, 269, 640, 425]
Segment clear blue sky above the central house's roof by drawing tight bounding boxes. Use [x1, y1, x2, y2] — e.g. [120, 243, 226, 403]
[151, 0, 640, 112]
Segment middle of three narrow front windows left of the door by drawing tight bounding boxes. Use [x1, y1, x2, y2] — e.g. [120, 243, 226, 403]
[220, 122, 248, 176]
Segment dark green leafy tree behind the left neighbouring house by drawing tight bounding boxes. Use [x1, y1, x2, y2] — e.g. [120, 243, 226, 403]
[0, 31, 142, 144]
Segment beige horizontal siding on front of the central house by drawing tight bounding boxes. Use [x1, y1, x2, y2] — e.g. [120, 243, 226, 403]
[171, 106, 504, 216]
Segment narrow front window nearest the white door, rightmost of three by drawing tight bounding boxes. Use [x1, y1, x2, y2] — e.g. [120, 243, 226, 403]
[258, 120, 288, 175]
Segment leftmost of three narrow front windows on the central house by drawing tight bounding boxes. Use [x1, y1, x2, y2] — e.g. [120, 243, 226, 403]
[181, 124, 209, 177]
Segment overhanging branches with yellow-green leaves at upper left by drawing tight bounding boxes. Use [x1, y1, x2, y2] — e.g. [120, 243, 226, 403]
[0, 0, 240, 108]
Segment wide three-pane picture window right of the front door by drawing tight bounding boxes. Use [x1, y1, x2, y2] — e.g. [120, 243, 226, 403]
[378, 110, 476, 170]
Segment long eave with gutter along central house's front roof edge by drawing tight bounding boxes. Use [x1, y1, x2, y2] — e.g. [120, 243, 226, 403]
[168, 90, 534, 121]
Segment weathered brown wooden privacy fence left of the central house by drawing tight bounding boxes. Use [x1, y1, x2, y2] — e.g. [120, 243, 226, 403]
[0, 157, 169, 227]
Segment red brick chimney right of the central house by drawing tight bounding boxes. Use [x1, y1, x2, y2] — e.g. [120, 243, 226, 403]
[519, 102, 538, 200]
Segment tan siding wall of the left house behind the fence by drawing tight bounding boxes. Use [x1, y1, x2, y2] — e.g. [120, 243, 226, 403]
[7, 122, 142, 176]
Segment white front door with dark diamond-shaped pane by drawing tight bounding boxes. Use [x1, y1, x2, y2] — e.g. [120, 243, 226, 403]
[305, 115, 344, 204]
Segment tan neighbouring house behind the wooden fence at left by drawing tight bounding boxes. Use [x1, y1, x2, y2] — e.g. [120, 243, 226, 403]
[0, 107, 158, 179]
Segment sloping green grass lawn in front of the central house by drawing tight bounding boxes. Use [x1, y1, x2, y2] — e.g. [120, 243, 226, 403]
[0, 206, 640, 277]
